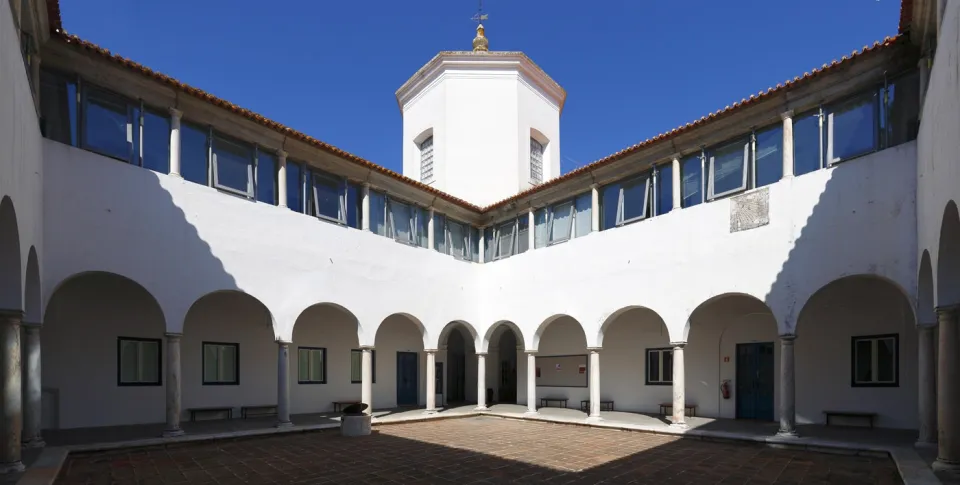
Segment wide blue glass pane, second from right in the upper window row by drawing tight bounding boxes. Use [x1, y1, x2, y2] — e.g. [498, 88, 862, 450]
[827, 93, 878, 162]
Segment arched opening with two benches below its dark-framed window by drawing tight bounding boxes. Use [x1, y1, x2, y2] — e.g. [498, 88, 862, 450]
[180, 290, 277, 419]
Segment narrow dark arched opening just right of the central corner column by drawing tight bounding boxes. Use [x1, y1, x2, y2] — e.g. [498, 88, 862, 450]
[483, 321, 527, 405]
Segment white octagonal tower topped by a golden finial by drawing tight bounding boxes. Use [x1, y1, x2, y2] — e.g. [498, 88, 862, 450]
[396, 11, 566, 206]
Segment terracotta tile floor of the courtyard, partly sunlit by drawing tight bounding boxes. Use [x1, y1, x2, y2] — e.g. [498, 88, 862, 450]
[57, 417, 902, 485]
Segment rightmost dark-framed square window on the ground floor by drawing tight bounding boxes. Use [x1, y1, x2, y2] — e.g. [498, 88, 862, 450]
[850, 334, 900, 387]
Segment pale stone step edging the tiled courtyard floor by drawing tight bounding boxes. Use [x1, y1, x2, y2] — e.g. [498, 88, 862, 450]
[11, 411, 940, 485]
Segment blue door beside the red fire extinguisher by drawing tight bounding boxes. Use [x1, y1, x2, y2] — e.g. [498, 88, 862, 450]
[736, 342, 773, 421]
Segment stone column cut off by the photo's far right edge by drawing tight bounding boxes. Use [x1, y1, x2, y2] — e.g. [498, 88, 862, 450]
[933, 306, 960, 470]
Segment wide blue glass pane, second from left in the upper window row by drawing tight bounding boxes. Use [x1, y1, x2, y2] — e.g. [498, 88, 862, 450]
[83, 87, 133, 161]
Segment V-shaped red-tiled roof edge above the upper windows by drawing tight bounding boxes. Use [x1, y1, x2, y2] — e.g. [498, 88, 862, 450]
[48, 27, 909, 214]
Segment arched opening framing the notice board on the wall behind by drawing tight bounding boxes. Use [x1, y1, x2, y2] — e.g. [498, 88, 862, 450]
[534, 315, 590, 408]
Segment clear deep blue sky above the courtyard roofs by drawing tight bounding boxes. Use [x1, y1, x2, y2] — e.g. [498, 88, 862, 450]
[60, 0, 900, 172]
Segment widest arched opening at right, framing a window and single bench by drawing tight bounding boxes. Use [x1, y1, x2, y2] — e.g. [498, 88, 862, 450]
[794, 275, 918, 429]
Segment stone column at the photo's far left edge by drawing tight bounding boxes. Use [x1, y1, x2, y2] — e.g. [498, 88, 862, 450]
[0, 310, 24, 474]
